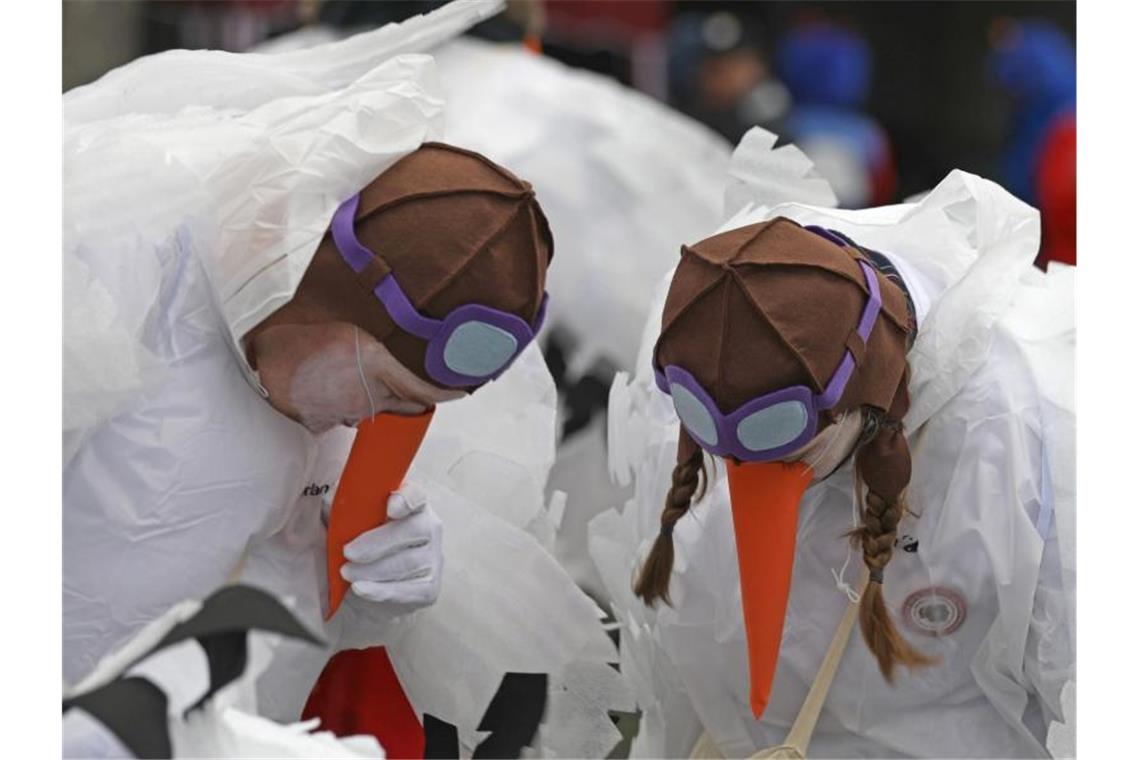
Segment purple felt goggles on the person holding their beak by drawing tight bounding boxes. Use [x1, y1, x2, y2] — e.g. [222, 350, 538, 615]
[332, 195, 547, 387]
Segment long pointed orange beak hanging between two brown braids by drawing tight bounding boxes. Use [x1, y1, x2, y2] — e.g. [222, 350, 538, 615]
[725, 460, 812, 719]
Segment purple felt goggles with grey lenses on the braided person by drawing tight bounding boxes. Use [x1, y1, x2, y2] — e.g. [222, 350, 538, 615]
[653, 238, 882, 461]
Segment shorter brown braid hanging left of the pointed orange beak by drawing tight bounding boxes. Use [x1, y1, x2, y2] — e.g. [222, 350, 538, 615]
[634, 430, 708, 606]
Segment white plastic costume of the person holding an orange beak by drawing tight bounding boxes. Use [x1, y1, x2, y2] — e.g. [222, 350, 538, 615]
[64, 2, 629, 755]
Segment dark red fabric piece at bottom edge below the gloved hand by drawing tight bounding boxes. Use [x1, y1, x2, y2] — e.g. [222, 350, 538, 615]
[301, 646, 424, 759]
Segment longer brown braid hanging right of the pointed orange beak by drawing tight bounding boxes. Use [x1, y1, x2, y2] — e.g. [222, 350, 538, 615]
[849, 378, 938, 684]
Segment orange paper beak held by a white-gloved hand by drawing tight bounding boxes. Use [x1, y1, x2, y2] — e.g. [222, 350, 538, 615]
[326, 409, 434, 620]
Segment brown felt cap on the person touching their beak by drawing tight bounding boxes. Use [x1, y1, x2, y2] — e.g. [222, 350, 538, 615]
[269, 142, 554, 382]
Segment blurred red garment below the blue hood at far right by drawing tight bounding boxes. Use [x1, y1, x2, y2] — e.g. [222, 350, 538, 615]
[1037, 113, 1076, 269]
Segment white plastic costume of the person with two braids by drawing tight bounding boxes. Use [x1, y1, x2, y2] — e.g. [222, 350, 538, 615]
[589, 130, 1075, 758]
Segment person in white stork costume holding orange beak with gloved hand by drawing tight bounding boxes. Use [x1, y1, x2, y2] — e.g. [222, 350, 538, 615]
[63, 2, 626, 757]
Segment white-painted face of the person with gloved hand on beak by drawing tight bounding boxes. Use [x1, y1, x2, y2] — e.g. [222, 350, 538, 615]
[251, 322, 466, 433]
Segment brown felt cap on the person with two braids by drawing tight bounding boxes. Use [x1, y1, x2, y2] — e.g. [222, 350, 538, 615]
[654, 218, 911, 430]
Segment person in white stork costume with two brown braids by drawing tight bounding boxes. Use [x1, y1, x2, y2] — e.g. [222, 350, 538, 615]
[589, 129, 1075, 758]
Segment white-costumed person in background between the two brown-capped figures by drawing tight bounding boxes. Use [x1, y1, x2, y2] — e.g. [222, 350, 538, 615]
[248, 2, 732, 600]
